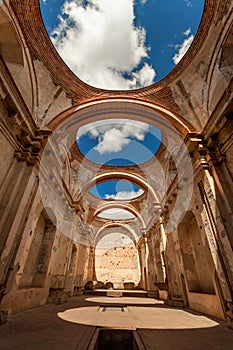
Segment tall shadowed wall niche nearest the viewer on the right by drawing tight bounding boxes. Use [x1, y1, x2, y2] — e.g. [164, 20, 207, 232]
[178, 211, 223, 318]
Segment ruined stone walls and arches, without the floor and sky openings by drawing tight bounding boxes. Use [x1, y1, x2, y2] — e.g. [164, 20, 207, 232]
[0, 0, 233, 349]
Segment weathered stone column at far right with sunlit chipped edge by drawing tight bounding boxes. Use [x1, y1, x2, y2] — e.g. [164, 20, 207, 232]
[198, 143, 233, 328]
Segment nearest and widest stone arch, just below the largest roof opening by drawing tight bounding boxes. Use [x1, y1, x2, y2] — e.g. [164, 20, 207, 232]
[48, 96, 195, 140]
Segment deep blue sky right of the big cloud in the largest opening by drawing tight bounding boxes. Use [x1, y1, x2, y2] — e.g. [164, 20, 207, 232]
[135, 0, 204, 81]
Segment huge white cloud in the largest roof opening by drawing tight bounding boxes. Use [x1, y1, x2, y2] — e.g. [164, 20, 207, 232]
[51, 0, 155, 89]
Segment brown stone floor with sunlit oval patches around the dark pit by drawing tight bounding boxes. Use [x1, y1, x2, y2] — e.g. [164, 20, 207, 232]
[0, 296, 233, 350]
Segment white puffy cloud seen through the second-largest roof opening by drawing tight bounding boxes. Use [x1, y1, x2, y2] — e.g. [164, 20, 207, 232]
[77, 119, 149, 155]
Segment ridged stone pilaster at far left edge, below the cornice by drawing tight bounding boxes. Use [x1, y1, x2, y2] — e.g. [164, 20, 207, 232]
[0, 159, 38, 296]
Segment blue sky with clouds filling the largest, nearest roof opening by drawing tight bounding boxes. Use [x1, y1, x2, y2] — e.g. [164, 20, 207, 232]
[40, 0, 204, 89]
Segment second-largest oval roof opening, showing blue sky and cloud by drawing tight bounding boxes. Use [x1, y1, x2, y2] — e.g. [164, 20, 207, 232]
[76, 118, 162, 166]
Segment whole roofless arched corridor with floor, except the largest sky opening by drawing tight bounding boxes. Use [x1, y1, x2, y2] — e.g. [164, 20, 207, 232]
[0, 0, 233, 350]
